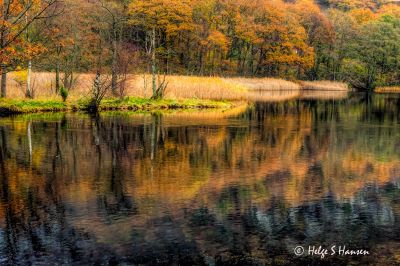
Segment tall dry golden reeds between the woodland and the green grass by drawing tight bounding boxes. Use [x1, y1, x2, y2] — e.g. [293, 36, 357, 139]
[7, 72, 348, 100]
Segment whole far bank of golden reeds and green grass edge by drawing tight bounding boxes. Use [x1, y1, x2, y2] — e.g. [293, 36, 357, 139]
[0, 72, 349, 115]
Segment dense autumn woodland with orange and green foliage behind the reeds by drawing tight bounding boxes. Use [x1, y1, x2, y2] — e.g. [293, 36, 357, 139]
[0, 0, 400, 96]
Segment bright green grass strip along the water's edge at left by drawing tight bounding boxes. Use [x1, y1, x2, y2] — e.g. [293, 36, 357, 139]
[0, 97, 234, 115]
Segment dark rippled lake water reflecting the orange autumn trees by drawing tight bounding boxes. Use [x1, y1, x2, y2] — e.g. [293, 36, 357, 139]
[0, 95, 400, 265]
